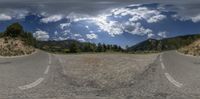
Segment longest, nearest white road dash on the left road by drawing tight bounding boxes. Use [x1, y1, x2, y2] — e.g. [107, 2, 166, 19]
[18, 78, 44, 90]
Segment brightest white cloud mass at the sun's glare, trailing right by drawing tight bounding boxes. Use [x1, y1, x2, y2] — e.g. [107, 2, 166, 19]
[69, 15, 153, 37]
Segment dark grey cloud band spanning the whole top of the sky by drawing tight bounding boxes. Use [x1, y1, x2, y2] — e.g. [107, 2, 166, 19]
[0, 0, 200, 16]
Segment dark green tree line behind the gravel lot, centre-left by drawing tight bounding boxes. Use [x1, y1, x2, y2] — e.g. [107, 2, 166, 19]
[36, 40, 124, 53]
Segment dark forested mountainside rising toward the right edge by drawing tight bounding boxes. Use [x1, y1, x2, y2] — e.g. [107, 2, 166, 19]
[128, 34, 200, 52]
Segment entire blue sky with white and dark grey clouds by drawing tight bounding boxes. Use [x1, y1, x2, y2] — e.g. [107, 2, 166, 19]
[0, 0, 200, 46]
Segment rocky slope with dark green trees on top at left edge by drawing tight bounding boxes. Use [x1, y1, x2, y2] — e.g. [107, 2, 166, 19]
[0, 23, 36, 56]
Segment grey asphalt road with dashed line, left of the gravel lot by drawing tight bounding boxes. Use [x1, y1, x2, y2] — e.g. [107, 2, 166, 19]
[0, 51, 69, 99]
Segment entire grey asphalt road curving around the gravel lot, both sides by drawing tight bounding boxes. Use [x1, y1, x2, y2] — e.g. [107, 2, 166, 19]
[0, 51, 200, 99]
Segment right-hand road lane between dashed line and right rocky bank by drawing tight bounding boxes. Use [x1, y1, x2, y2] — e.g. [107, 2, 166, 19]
[161, 51, 200, 91]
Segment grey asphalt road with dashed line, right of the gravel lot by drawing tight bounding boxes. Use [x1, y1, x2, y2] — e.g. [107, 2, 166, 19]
[129, 51, 200, 99]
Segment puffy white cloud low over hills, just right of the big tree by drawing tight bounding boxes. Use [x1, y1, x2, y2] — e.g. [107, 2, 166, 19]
[33, 30, 49, 41]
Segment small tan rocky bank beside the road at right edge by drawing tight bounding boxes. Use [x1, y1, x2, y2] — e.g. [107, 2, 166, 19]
[179, 40, 200, 56]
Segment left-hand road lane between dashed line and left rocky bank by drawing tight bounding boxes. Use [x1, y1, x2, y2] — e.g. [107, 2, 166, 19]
[0, 51, 49, 91]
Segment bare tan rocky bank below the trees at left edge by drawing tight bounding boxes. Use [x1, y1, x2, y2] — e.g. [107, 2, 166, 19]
[0, 37, 35, 56]
